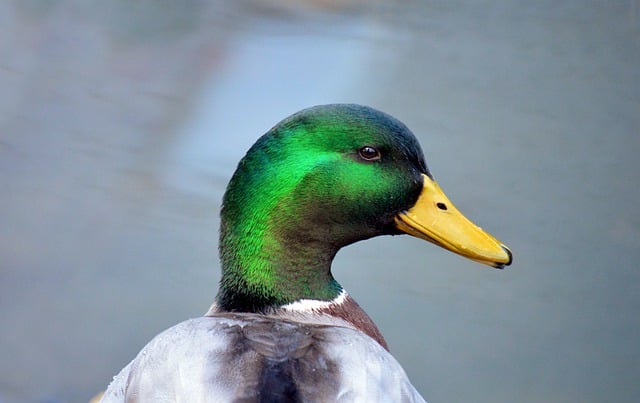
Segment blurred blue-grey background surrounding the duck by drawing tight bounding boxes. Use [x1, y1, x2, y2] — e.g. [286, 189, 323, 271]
[0, 0, 640, 403]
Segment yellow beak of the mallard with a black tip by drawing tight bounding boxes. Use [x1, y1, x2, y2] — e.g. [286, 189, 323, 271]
[395, 174, 513, 269]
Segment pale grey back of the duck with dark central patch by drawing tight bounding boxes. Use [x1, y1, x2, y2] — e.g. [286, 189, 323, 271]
[103, 313, 423, 403]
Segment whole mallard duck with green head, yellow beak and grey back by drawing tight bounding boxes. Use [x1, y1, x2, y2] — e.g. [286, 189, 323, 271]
[101, 104, 513, 403]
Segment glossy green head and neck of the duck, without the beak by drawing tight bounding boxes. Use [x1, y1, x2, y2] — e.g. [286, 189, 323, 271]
[217, 105, 512, 311]
